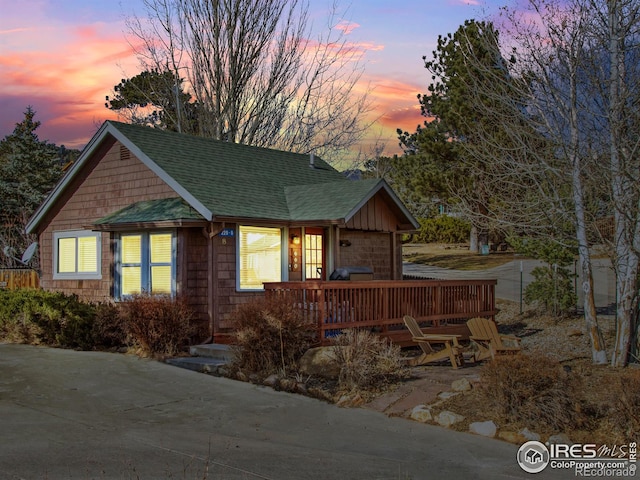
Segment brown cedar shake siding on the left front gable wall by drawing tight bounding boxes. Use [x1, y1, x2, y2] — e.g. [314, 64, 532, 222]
[40, 142, 180, 301]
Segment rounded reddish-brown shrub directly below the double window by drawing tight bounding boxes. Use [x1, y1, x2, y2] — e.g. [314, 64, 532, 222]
[120, 295, 194, 356]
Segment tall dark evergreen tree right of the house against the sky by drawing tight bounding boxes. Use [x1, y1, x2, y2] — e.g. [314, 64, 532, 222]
[398, 20, 511, 251]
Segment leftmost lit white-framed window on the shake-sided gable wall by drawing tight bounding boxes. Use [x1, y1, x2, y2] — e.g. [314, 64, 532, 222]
[53, 230, 102, 280]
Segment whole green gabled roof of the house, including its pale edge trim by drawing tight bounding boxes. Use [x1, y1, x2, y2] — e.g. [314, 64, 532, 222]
[27, 121, 418, 232]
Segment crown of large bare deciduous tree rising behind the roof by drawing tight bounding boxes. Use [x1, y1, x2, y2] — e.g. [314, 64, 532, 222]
[124, 0, 371, 159]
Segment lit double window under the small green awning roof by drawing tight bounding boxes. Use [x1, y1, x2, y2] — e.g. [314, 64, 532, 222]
[116, 232, 176, 298]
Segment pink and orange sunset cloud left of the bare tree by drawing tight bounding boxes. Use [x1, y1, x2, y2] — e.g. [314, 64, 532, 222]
[0, 15, 138, 148]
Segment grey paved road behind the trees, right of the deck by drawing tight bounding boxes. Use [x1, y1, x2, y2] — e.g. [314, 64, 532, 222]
[403, 259, 615, 313]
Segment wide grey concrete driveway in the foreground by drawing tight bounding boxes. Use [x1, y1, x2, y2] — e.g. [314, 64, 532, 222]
[0, 344, 569, 480]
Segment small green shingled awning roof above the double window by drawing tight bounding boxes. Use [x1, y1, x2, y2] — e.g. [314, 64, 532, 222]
[94, 198, 203, 225]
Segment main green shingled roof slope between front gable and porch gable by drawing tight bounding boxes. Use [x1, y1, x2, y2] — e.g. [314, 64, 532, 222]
[109, 122, 352, 220]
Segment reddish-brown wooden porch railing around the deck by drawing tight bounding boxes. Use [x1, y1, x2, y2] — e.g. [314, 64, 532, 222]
[264, 280, 497, 345]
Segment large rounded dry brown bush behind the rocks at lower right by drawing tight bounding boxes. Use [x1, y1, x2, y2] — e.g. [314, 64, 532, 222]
[479, 354, 586, 431]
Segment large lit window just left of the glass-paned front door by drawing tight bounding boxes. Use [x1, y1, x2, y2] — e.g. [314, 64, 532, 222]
[238, 226, 282, 290]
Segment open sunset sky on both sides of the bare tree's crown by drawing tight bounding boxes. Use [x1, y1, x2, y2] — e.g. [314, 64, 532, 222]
[0, 0, 505, 158]
